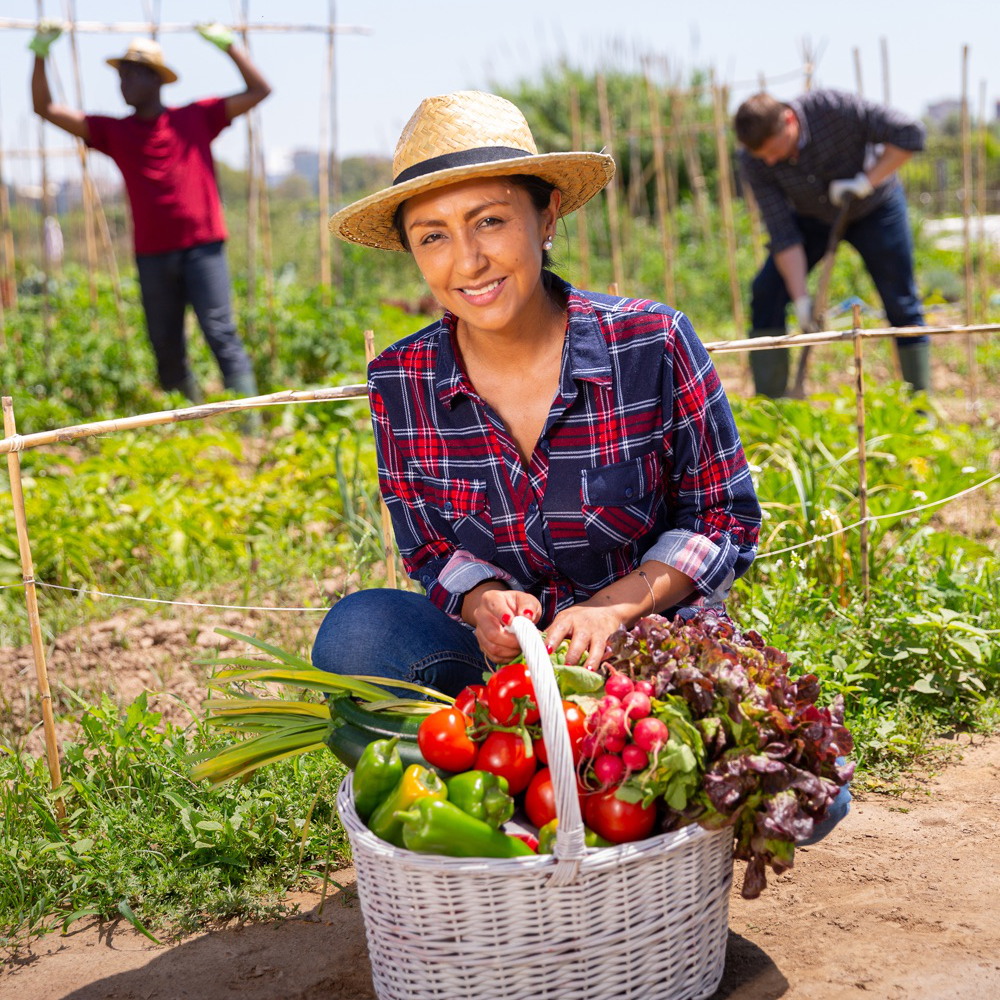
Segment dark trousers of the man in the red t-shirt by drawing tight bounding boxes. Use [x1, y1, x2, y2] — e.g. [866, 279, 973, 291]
[135, 241, 253, 391]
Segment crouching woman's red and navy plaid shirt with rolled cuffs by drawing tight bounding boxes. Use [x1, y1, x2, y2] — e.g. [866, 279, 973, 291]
[368, 275, 760, 626]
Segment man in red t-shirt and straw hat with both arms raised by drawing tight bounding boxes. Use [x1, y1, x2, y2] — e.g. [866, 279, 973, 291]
[29, 22, 271, 402]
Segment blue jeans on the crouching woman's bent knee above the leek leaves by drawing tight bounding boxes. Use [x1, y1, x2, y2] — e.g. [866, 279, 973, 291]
[312, 590, 493, 696]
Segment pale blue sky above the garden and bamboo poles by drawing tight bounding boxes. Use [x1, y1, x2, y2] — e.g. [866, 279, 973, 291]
[0, 0, 1000, 188]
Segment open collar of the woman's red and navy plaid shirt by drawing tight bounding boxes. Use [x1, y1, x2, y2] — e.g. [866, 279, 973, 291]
[434, 272, 611, 407]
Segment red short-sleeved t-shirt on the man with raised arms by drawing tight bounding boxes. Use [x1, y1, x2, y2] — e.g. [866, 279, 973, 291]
[87, 97, 229, 254]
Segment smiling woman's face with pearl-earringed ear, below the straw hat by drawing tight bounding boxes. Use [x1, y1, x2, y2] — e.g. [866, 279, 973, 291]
[403, 177, 560, 332]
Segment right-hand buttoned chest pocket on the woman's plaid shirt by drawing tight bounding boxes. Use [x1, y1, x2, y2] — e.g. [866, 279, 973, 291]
[581, 452, 663, 553]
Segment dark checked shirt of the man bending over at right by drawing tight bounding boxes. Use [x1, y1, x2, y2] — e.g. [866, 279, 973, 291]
[739, 90, 926, 253]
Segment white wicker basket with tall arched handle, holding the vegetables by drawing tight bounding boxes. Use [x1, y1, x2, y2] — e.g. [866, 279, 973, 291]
[337, 619, 733, 1000]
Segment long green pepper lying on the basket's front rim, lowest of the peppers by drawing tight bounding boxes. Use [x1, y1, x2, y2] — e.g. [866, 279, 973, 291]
[396, 796, 535, 858]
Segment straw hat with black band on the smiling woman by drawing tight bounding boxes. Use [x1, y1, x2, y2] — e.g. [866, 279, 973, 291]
[330, 90, 615, 250]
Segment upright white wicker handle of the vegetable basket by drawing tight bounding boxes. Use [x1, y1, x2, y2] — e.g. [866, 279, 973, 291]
[507, 615, 587, 885]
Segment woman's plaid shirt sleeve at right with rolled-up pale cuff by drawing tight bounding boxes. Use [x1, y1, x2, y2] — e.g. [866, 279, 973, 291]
[643, 314, 761, 597]
